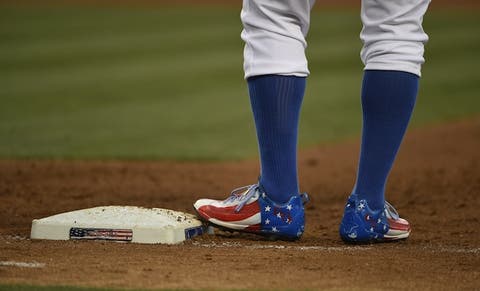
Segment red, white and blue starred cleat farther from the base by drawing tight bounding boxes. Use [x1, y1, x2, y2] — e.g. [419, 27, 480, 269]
[340, 195, 411, 243]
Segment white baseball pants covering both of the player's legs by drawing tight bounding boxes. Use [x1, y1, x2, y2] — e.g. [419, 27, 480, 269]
[241, 0, 430, 78]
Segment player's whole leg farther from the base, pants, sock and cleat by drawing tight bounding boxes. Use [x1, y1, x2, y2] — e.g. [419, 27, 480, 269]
[340, 0, 430, 242]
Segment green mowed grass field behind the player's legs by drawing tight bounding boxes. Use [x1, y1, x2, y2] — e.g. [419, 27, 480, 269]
[0, 4, 480, 160]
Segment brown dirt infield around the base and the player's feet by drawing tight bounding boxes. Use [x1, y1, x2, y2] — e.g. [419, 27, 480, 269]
[0, 118, 480, 290]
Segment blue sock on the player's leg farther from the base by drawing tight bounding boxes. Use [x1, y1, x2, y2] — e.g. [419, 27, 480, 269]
[352, 71, 419, 209]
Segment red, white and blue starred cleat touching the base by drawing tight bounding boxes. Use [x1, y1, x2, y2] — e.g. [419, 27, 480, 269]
[193, 184, 308, 240]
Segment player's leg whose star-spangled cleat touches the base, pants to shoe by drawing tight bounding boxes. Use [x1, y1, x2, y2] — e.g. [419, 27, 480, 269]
[194, 0, 313, 238]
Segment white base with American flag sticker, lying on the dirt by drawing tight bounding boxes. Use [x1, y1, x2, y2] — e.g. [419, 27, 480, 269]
[30, 206, 204, 244]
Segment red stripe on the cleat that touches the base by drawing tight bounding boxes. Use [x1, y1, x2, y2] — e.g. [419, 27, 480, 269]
[197, 202, 260, 221]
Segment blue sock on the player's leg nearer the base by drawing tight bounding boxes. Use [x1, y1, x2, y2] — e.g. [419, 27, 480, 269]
[248, 75, 306, 203]
